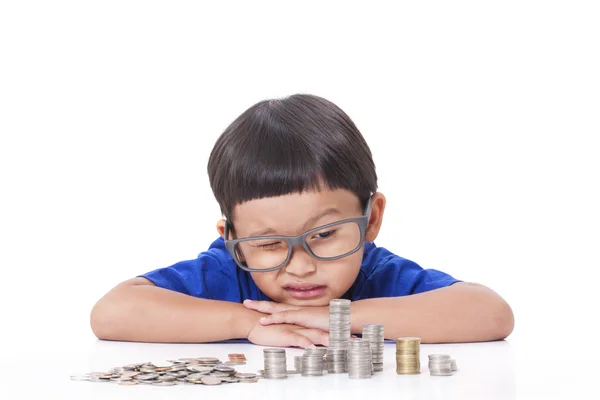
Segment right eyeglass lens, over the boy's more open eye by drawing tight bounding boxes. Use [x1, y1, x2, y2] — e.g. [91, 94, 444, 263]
[306, 222, 360, 258]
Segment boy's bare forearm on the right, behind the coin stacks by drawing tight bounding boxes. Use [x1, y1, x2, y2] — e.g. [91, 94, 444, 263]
[352, 283, 514, 343]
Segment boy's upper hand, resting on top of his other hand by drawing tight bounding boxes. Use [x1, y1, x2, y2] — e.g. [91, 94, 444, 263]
[244, 300, 329, 332]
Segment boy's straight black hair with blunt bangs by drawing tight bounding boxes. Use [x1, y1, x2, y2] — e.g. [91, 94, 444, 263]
[208, 94, 377, 220]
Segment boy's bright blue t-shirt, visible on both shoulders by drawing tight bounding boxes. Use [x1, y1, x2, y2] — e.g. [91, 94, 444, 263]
[139, 237, 459, 303]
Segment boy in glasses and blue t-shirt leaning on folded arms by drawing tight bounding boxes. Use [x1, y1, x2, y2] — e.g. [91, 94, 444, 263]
[91, 94, 514, 348]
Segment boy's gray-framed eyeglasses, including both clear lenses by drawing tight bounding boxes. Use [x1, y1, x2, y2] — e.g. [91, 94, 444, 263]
[224, 197, 371, 272]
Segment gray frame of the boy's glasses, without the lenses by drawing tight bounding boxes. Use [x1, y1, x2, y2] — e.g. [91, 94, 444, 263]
[224, 196, 371, 272]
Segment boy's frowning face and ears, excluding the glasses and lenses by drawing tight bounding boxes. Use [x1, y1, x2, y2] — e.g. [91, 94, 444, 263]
[217, 189, 385, 306]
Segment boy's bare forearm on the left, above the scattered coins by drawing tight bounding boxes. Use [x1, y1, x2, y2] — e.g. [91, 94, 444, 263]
[91, 285, 263, 343]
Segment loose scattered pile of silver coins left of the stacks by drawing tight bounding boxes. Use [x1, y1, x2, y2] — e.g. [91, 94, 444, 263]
[71, 357, 258, 386]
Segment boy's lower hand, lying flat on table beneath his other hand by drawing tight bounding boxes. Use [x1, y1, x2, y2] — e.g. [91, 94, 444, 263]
[248, 322, 329, 349]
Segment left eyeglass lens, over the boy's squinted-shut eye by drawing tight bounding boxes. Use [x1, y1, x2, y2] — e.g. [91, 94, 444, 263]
[235, 239, 288, 270]
